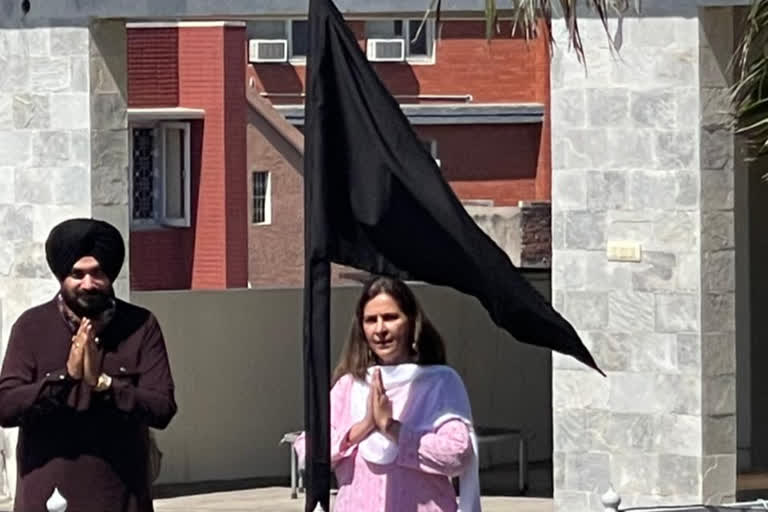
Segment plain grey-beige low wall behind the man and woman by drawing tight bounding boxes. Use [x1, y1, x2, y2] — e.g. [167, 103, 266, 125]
[132, 277, 552, 484]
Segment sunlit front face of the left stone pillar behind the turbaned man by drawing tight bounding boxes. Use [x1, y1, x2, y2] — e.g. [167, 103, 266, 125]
[0, 23, 91, 348]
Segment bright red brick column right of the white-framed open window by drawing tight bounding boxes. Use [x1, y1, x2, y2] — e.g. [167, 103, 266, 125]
[179, 23, 248, 288]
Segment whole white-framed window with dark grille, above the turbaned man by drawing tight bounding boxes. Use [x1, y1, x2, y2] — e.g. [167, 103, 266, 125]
[131, 123, 190, 227]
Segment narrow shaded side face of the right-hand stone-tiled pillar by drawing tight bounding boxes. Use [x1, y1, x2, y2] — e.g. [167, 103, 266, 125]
[699, 7, 744, 503]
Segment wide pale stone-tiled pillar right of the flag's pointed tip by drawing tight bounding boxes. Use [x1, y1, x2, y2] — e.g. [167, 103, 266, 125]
[552, 0, 736, 512]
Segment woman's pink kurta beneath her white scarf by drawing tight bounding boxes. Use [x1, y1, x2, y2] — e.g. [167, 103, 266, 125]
[297, 375, 472, 512]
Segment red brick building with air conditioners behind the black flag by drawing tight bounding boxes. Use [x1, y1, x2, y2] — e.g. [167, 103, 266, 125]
[128, 16, 551, 289]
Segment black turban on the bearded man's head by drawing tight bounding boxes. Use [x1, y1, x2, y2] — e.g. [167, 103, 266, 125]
[45, 219, 125, 282]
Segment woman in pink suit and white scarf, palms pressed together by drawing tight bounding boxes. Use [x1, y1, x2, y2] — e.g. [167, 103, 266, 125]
[312, 277, 480, 512]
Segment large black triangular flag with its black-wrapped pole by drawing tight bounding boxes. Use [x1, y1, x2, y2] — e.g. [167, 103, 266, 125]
[304, 0, 602, 512]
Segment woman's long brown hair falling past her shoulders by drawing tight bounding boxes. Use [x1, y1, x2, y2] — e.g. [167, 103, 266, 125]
[333, 277, 446, 384]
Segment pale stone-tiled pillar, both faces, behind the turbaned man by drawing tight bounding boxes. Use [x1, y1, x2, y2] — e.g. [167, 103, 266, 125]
[0, 18, 129, 493]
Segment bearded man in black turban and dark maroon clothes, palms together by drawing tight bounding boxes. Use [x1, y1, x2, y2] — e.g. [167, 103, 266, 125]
[0, 219, 176, 512]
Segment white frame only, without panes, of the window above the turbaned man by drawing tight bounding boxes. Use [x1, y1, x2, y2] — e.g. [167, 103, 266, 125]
[128, 121, 192, 229]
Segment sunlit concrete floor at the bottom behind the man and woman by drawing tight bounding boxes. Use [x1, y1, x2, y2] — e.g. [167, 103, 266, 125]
[155, 487, 552, 512]
